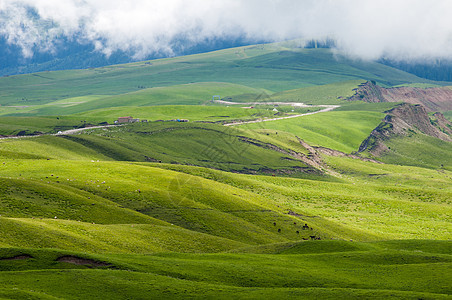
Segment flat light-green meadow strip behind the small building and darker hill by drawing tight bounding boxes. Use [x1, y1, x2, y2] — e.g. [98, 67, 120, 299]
[0, 103, 323, 136]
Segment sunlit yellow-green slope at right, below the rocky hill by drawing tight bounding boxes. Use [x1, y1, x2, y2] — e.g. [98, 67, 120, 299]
[161, 161, 452, 240]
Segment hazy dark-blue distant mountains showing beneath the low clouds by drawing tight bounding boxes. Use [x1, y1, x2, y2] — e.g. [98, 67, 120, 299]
[0, 37, 452, 81]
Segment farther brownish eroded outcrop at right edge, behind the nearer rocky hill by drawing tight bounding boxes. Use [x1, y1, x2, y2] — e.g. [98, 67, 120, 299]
[348, 81, 452, 112]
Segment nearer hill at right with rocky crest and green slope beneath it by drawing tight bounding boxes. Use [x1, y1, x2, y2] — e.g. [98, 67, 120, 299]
[359, 104, 452, 170]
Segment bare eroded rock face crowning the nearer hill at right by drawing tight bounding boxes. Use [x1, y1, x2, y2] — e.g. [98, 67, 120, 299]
[358, 103, 452, 156]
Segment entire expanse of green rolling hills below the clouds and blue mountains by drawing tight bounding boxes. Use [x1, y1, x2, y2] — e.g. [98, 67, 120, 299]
[0, 43, 452, 299]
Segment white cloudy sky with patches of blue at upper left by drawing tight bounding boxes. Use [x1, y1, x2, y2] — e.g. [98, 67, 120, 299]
[0, 0, 452, 59]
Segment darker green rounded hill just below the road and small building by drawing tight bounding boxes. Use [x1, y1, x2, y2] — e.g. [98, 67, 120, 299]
[0, 122, 313, 173]
